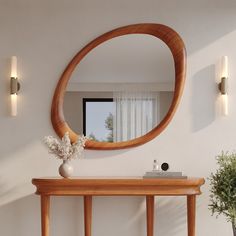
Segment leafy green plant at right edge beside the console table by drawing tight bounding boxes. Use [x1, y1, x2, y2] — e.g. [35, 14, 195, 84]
[209, 152, 236, 236]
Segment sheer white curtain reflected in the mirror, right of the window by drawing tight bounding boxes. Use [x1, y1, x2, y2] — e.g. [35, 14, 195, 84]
[113, 91, 160, 142]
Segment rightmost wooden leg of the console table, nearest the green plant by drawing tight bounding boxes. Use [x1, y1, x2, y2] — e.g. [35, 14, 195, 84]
[187, 195, 196, 236]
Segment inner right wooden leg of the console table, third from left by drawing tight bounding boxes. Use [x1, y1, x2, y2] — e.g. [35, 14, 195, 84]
[146, 196, 154, 236]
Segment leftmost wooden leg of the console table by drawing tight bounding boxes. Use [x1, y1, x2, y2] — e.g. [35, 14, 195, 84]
[41, 195, 50, 236]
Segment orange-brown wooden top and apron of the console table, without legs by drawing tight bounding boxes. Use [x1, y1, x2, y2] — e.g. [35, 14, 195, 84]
[32, 177, 204, 196]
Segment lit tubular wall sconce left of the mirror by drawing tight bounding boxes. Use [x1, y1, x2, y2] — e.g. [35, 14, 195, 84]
[10, 56, 20, 116]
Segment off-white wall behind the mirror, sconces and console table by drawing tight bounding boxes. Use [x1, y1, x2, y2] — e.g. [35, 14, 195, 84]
[0, 0, 236, 236]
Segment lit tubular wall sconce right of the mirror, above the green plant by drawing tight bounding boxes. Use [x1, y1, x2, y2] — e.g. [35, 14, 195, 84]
[218, 56, 229, 116]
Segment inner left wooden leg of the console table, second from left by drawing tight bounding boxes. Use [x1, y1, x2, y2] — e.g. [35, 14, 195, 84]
[84, 196, 92, 236]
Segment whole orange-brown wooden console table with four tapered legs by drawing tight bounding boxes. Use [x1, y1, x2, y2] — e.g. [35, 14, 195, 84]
[32, 177, 204, 236]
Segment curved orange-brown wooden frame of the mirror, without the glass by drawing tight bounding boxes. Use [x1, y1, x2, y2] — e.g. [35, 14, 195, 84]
[51, 23, 186, 150]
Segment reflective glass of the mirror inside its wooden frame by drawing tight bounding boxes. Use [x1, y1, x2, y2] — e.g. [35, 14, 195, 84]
[63, 34, 175, 142]
